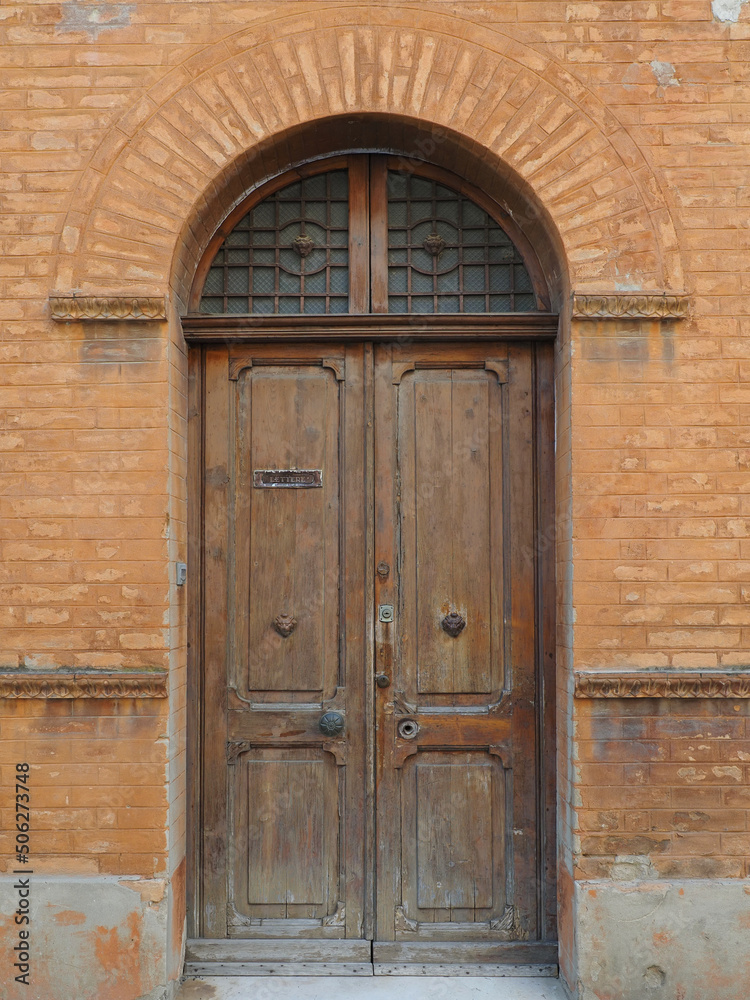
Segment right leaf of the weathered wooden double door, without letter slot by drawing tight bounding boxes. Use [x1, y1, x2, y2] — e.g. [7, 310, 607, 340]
[375, 344, 539, 963]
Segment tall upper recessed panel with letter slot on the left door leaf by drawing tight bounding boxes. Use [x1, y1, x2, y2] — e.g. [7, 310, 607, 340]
[237, 364, 340, 699]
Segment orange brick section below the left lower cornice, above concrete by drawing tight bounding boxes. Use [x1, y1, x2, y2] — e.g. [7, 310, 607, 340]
[0, 699, 167, 876]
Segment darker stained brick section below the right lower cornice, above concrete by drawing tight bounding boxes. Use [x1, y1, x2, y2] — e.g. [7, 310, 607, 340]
[575, 699, 750, 879]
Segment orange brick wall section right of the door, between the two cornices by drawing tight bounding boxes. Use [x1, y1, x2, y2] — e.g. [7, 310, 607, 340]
[572, 320, 750, 668]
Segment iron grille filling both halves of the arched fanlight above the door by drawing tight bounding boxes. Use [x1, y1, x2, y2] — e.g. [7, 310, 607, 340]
[200, 169, 539, 316]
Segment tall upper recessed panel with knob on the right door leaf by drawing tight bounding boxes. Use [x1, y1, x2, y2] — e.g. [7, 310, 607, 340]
[396, 367, 503, 704]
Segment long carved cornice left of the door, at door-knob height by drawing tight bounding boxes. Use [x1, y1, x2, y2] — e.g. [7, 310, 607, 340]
[0, 670, 168, 699]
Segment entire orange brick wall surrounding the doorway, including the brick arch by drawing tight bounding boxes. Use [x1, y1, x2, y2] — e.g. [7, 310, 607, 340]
[0, 0, 750, 996]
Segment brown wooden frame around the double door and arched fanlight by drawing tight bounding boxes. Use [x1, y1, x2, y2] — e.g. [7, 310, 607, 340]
[183, 154, 557, 972]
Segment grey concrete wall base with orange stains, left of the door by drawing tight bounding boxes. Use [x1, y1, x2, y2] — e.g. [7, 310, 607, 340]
[0, 875, 176, 1000]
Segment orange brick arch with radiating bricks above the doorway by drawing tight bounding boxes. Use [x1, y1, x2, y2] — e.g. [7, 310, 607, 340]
[55, 7, 683, 302]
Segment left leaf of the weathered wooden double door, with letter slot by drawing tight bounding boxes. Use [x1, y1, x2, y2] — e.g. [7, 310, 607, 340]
[204, 345, 370, 961]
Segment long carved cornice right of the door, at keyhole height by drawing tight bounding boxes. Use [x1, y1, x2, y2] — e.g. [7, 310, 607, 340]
[574, 670, 750, 698]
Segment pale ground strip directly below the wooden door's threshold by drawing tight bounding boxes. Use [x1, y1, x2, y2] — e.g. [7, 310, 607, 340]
[176, 976, 567, 1000]
